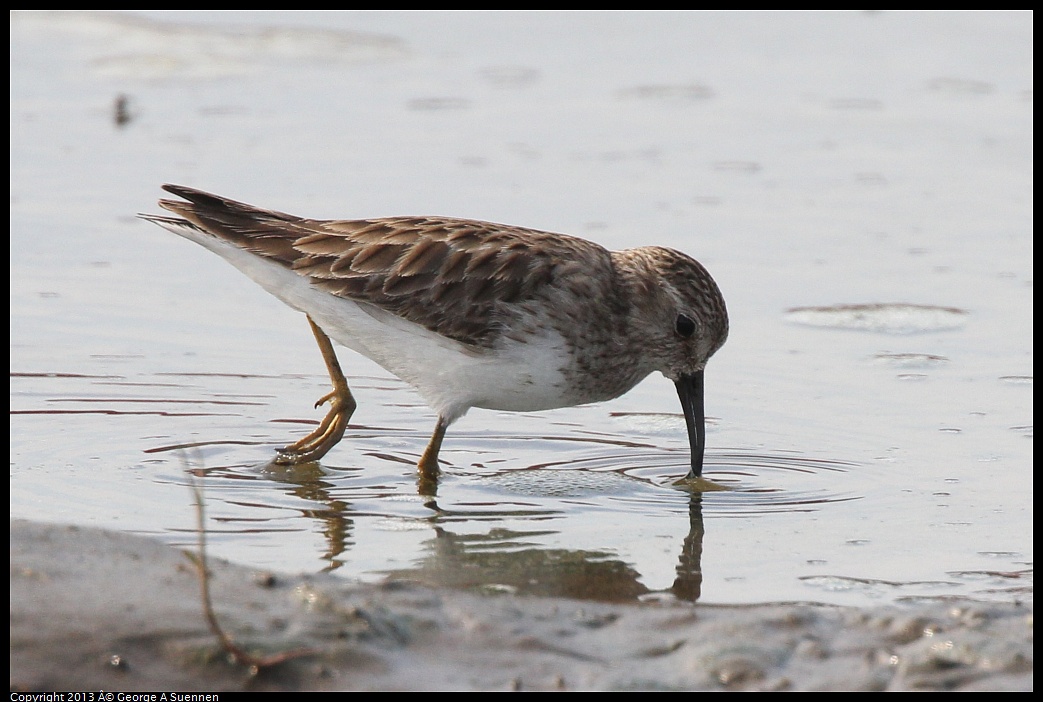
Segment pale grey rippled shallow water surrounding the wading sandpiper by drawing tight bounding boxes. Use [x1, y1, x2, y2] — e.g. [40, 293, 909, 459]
[10, 11, 1033, 604]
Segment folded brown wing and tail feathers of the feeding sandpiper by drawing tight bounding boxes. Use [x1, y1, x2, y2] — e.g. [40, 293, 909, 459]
[160, 186, 611, 346]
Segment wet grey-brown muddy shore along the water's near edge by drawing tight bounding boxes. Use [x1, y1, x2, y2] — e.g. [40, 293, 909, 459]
[10, 521, 1033, 699]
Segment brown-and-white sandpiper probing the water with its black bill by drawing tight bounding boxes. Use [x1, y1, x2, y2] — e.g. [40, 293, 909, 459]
[141, 185, 728, 479]
